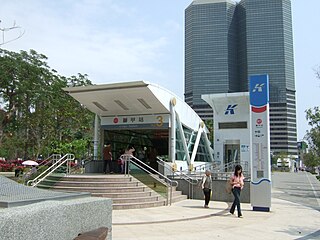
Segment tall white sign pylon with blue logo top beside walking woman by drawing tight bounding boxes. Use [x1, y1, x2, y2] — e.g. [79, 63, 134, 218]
[250, 75, 271, 211]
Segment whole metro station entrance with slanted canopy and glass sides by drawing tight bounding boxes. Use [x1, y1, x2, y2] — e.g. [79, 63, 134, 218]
[64, 81, 214, 172]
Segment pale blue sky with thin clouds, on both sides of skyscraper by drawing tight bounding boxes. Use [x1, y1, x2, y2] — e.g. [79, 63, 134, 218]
[0, 0, 320, 140]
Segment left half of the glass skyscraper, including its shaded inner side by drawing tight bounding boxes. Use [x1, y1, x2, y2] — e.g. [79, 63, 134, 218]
[185, 2, 237, 109]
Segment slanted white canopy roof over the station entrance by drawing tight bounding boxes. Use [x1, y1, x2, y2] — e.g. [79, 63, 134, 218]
[63, 81, 202, 132]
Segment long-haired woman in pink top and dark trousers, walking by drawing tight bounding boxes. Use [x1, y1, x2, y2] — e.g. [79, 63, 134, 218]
[230, 165, 244, 218]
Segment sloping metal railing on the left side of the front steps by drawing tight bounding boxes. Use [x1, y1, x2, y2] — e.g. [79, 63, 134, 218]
[27, 154, 74, 187]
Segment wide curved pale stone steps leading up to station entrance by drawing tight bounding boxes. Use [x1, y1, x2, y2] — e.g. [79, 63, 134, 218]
[38, 174, 187, 209]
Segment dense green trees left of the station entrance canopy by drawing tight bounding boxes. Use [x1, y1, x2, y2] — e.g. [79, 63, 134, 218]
[0, 49, 93, 158]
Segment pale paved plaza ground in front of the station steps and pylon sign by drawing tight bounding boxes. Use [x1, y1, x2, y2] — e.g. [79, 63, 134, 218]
[112, 172, 320, 240]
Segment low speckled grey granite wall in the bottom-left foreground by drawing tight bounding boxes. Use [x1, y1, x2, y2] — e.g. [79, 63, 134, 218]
[0, 197, 112, 240]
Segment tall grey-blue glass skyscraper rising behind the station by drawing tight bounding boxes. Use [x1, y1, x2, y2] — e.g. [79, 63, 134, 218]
[185, 0, 297, 155]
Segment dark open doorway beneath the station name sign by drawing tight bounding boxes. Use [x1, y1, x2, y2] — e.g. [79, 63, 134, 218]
[104, 129, 169, 170]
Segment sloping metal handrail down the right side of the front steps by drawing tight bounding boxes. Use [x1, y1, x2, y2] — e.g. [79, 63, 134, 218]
[122, 154, 178, 205]
